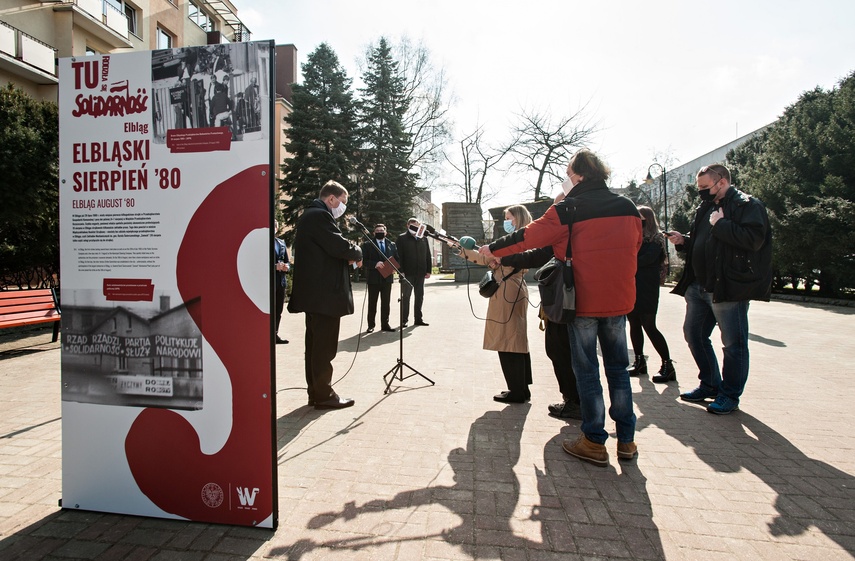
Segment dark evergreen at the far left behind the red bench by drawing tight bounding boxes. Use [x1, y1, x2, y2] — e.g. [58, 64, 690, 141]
[0, 84, 59, 288]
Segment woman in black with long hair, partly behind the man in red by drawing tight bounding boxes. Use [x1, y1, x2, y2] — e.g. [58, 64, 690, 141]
[626, 206, 677, 383]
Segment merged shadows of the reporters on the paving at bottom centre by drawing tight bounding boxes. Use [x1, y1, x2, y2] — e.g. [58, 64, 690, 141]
[268, 404, 663, 561]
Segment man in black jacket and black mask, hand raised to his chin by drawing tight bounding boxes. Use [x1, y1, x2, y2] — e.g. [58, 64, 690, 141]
[665, 164, 772, 415]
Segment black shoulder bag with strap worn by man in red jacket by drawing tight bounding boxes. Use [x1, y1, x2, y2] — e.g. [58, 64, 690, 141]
[534, 201, 576, 323]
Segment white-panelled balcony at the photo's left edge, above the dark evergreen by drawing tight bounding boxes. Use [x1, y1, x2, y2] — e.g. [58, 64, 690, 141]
[0, 22, 58, 85]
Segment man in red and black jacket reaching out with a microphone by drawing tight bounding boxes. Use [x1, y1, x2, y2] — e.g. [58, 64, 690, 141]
[481, 149, 642, 467]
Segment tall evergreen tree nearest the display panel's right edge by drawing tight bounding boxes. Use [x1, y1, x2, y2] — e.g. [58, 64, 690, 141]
[280, 43, 356, 232]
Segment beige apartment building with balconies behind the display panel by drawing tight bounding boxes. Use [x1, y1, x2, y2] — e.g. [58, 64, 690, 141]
[0, 0, 250, 100]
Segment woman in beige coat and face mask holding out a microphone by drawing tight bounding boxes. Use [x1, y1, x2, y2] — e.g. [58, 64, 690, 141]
[462, 205, 531, 403]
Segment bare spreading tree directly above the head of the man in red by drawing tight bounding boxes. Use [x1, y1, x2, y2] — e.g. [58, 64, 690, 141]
[508, 107, 598, 200]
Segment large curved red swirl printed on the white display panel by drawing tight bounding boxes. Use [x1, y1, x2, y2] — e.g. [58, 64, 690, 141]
[125, 165, 275, 525]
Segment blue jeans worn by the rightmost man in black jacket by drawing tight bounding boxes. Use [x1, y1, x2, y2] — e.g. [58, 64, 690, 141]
[683, 282, 749, 402]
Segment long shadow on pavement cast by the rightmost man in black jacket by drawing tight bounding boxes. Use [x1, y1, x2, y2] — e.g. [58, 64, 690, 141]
[633, 372, 855, 557]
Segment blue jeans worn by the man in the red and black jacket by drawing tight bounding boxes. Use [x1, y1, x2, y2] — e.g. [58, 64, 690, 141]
[568, 316, 635, 444]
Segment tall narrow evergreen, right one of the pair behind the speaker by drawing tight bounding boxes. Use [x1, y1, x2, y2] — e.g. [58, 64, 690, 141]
[355, 38, 419, 232]
